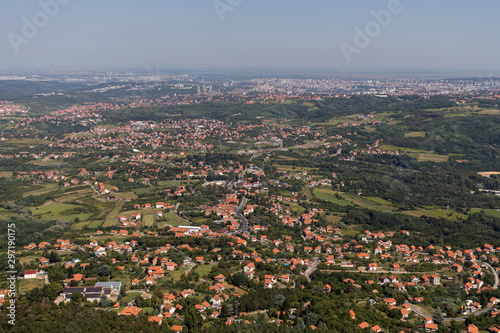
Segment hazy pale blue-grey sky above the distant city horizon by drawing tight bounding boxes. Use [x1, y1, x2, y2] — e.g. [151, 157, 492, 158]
[0, 0, 500, 70]
